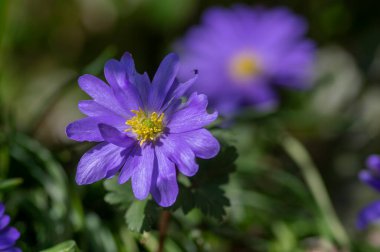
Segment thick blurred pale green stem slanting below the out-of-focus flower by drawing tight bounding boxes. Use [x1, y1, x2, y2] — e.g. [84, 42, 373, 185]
[281, 134, 350, 250]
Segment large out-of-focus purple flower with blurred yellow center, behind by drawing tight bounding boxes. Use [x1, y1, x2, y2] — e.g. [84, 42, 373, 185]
[177, 5, 315, 116]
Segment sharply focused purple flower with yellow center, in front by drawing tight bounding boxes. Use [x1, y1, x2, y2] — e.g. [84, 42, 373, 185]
[66, 53, 219, 207]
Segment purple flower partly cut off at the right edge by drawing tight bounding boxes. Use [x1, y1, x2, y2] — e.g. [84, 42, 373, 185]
[356, 155, 380, 229]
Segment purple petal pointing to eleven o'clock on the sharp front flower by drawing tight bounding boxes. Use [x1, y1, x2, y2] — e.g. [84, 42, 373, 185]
[104, 60, 142, 111]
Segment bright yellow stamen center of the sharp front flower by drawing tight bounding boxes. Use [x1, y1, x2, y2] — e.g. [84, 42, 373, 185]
[125, 108, 164, 145]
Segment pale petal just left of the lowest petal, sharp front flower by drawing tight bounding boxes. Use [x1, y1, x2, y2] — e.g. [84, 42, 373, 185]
[132, 145, 154, 200]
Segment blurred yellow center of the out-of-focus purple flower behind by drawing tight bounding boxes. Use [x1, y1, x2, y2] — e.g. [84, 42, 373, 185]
[229, 52, 261, 81]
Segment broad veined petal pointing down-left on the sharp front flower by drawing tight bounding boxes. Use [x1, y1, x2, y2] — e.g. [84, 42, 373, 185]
[76, 143, 128, 185]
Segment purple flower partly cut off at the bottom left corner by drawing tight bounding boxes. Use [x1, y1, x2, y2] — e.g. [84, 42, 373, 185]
[0, 203, 21, 252]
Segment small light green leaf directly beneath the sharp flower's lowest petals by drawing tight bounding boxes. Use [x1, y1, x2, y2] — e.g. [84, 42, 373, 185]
[125, 200, 160, 233]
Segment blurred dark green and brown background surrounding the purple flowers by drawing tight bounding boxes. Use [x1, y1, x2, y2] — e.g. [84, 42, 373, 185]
[0, 0, 380, 252]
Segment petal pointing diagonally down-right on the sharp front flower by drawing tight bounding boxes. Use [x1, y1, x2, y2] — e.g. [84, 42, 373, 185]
[161, 134, 199, 177]
